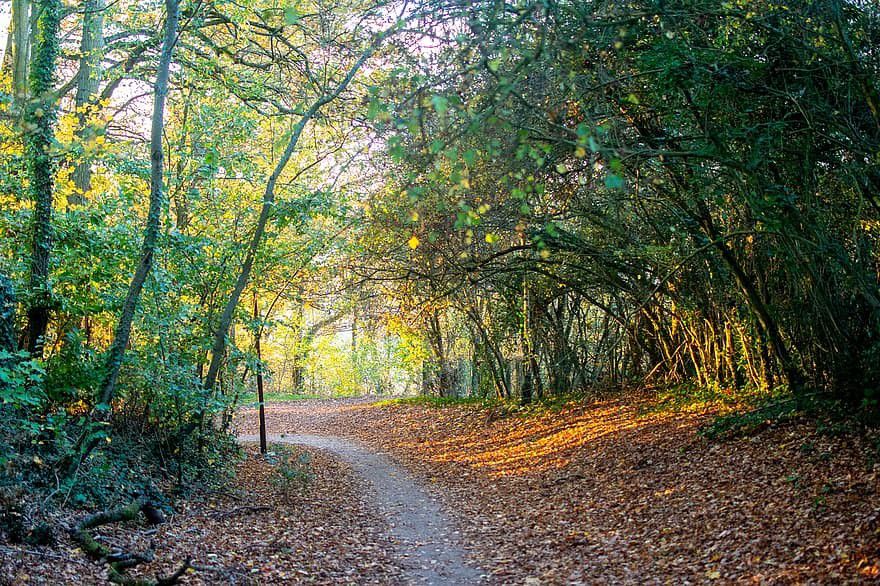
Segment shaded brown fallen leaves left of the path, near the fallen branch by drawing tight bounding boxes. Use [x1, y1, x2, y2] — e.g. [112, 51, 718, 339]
[0, 449, 401, 585]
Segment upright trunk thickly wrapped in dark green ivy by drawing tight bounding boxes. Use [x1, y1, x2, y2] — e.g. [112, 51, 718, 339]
[19, 0, 61, 356]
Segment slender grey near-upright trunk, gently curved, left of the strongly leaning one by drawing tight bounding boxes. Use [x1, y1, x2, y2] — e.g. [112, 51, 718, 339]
[101, 0, 180, 405]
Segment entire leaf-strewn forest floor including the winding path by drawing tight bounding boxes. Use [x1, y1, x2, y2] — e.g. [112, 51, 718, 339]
[6, 390, 880, 586]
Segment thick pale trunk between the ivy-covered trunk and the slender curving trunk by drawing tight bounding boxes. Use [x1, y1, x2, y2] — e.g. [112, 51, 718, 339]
[68, 0, 104, 205]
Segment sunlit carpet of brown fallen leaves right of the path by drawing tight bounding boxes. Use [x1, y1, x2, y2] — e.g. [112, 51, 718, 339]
[232, 399, 880, 584]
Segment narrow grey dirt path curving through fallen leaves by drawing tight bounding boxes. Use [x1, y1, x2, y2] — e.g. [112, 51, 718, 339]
[239, 434, 481, 586]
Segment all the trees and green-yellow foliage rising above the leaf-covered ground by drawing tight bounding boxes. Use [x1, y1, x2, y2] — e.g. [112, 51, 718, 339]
[0, 0, 880, 568]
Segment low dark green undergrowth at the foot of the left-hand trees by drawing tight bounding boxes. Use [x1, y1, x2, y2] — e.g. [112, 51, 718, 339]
[0, 346, 240, 543]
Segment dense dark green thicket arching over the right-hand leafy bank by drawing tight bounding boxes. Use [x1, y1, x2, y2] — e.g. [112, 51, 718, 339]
[360, 1, 880, 408]
